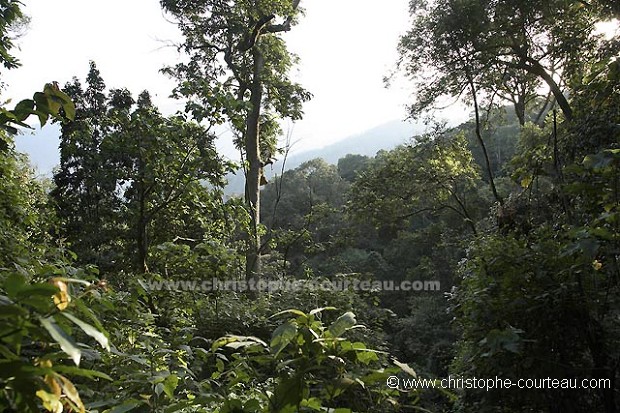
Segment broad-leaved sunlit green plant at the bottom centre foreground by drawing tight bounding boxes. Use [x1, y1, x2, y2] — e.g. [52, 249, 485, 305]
[208, 307, 410, 413]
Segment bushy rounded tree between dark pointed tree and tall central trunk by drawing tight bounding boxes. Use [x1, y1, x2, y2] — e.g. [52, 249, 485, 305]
[109, 90, 229, 272]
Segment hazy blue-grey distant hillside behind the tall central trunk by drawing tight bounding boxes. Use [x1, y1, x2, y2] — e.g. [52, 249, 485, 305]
[226, 120, 424, 195]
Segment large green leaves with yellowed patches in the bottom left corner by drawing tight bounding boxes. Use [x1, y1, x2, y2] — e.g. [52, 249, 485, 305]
[0, 260, 112, 412]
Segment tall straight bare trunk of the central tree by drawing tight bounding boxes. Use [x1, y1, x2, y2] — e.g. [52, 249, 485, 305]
[245, 45, 264, 279]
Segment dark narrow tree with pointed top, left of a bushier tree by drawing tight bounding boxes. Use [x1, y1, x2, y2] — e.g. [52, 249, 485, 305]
[51, 62, 120, 268]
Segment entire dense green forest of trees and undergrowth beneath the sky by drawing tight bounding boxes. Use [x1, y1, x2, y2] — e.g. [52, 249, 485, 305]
[0, 0, 620, 413]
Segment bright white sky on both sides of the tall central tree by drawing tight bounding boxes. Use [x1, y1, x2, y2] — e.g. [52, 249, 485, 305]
[3, 0, 422, 159]
